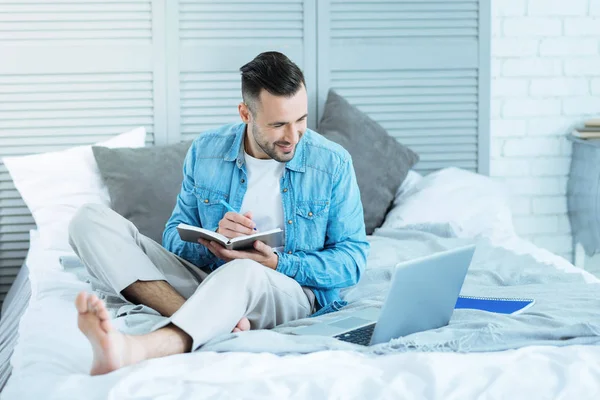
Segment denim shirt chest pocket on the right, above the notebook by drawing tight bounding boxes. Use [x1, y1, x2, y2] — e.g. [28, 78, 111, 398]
[296, 201, 329, 251]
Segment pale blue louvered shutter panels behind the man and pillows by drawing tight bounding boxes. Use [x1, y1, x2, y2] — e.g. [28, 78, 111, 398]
[0, 0, 490, 308]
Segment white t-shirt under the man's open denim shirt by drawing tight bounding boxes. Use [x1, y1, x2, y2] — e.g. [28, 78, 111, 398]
[240, 152, 285, 238]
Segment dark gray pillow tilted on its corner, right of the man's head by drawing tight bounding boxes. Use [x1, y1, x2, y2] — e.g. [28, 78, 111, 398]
[317, 89, 419, 235]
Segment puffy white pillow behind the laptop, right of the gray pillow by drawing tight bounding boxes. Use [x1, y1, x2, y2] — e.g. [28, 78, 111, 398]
[382, 167, 515, 238]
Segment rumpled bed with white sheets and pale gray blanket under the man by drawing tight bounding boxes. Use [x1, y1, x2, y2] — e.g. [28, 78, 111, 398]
[2, 163, 600, 399]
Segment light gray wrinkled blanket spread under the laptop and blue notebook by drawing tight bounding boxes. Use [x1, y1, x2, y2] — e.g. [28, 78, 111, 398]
[65, 224, 600, 355]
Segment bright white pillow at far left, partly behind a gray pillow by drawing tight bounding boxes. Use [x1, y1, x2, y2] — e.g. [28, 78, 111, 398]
[2, 127, 146, 251]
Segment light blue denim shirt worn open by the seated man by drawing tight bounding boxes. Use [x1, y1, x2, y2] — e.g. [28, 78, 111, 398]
[163, 123, 369, 316]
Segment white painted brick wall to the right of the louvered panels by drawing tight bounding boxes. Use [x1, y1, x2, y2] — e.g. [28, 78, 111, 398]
[491, 0, 600, 259]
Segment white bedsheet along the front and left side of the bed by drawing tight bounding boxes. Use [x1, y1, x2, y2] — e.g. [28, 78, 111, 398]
[2, 228, 600, 400]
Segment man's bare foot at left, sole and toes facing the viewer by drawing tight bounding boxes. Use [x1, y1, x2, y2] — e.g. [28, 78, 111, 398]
[75, 292, 145, 375]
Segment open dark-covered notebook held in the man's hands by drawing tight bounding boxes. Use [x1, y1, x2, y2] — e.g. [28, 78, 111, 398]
[177, 224, 284, 250]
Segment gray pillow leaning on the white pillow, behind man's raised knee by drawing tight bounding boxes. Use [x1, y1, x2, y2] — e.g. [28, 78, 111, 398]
[92, 141, 192, 243]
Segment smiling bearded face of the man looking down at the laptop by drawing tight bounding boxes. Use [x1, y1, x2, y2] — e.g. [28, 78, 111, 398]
[248, 86, 308, 162]
